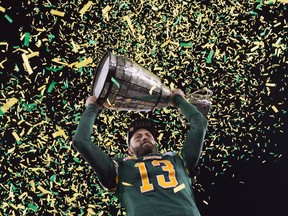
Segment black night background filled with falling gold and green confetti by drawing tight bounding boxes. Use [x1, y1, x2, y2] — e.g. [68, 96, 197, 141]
[0, 0, 288, 216]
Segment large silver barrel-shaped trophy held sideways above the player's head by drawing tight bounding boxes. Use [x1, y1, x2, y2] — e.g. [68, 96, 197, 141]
[92, 52, 212, 115]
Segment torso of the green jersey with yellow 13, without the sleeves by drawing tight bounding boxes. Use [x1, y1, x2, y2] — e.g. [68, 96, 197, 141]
[115, 152, 200, 216]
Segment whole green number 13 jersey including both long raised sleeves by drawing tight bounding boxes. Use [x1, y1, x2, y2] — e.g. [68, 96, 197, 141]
[73, 95, 207, 216]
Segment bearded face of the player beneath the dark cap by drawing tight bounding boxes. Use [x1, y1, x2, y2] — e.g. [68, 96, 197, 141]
[128, 128, 157, 157]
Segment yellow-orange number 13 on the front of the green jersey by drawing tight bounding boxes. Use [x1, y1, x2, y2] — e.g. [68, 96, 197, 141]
[135, 160, 178, 193]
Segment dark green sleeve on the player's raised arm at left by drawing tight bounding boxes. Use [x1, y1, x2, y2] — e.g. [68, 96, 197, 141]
[72, 104, 117, 189]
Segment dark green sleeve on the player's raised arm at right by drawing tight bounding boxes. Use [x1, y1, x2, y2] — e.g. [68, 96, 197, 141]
[173, 95, 208, 176]
